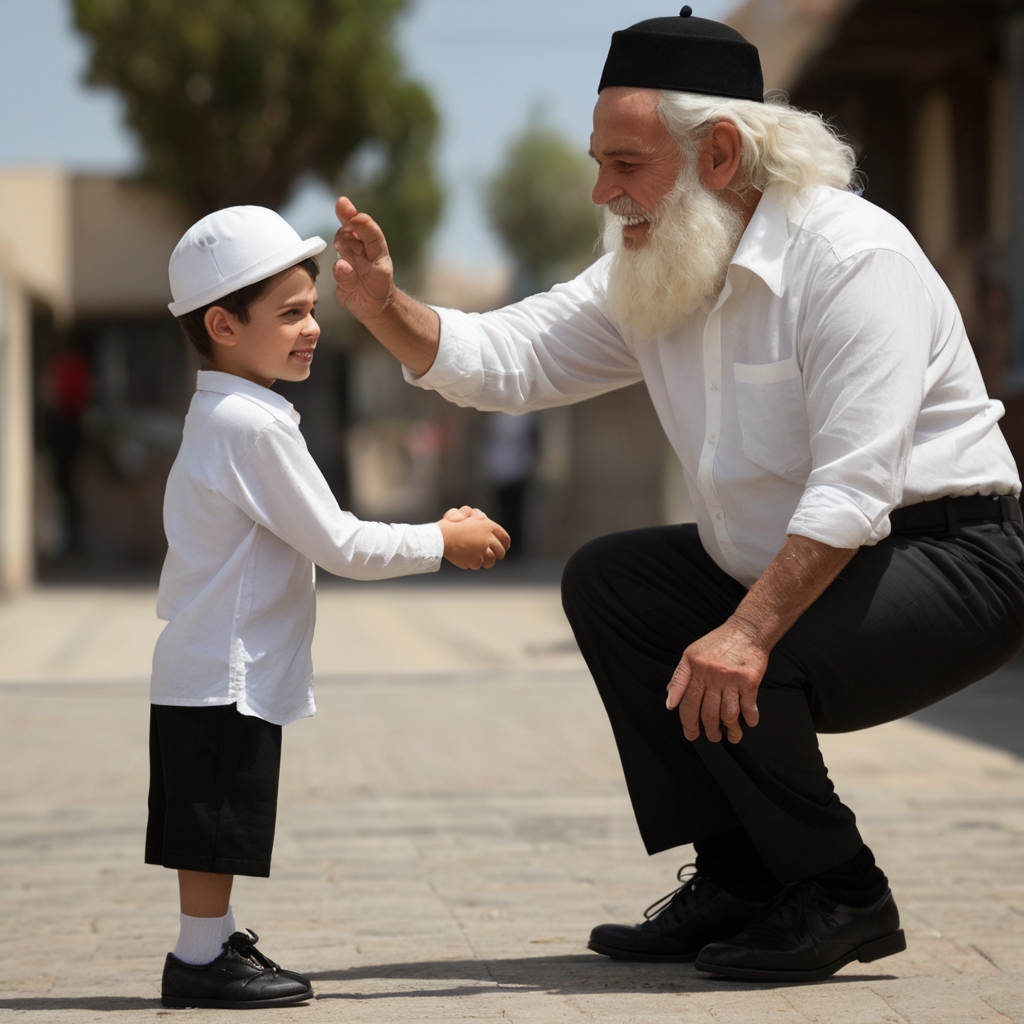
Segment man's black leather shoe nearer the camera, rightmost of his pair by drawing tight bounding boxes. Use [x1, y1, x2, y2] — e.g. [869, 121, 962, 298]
[694, 882, 906, 981]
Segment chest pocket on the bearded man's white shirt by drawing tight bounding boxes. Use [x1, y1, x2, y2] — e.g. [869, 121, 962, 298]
[732, 358, 811, 483]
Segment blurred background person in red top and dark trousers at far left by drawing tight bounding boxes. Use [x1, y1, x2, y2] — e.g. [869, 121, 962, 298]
[40, 348, 92, 554]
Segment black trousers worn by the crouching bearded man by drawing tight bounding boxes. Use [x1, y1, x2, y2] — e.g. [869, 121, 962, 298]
[562, 523, 1024, 883]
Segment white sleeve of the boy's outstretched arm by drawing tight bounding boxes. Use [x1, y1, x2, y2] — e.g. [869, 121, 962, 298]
[225, 421, 444, 580]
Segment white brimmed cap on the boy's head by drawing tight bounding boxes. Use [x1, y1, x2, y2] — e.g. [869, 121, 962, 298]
[167, 206, 327, 316]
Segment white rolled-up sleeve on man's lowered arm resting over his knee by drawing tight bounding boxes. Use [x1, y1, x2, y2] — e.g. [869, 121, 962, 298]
[786, 250, 941, 548]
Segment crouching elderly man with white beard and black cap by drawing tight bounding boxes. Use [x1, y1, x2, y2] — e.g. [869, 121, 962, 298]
[335, 7, 1024, 981]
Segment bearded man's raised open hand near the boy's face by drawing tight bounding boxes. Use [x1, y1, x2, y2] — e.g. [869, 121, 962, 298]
[334, 196, 394, 322]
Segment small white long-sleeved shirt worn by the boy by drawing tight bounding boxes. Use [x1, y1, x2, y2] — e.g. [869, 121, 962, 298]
[151, 372, 444, 725]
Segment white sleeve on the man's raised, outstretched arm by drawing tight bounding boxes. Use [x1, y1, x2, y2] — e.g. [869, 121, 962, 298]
[406, 257, 642, 413]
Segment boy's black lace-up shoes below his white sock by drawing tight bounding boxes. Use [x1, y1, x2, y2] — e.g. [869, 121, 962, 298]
[161, 932, 313, 1010]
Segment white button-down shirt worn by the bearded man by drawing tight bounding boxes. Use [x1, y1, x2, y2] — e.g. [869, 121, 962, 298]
[407, 188, 1020, 587]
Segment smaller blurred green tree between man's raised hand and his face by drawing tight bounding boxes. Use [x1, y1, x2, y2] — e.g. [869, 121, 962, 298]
[487, 119, 598, 296]
